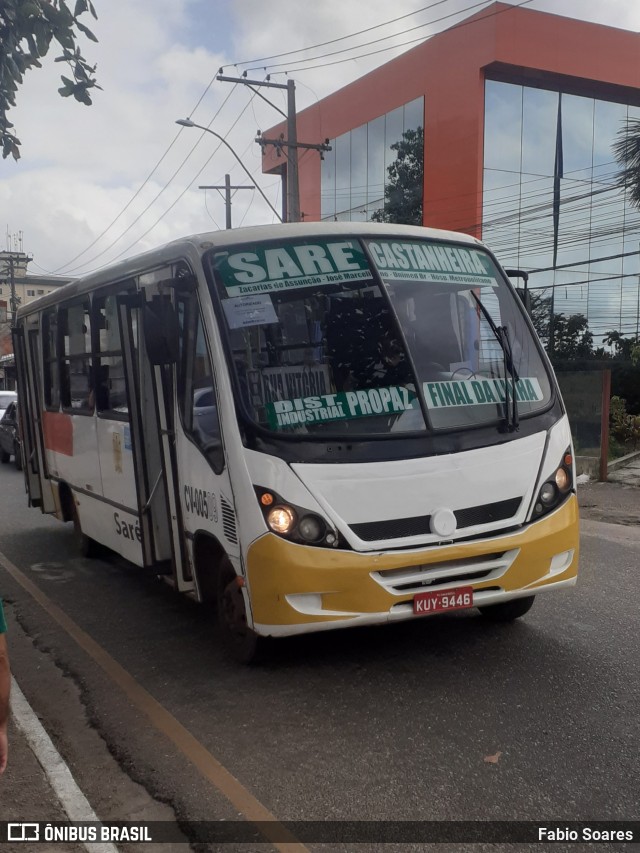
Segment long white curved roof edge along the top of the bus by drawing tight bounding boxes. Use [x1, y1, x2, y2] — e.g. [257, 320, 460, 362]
[17, 222, 484, 318]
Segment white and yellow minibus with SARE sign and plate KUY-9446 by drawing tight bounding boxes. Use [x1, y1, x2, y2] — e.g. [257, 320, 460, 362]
[14, 223, 578, 660]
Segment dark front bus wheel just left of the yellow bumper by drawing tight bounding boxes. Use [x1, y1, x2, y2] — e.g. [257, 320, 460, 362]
[217, 559, 265, 663]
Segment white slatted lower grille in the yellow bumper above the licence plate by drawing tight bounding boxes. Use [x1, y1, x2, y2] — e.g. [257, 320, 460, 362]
[371, 548, 519, 595]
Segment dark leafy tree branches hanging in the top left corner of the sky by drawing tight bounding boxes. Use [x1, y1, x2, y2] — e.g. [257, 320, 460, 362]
[0, 0, 100, 160]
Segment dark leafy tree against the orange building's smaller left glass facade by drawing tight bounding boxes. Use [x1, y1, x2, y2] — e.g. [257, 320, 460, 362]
[371, 127, 424, 225]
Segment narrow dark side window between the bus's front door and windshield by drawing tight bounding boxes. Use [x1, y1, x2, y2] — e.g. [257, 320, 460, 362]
[177, 297, 223, 470]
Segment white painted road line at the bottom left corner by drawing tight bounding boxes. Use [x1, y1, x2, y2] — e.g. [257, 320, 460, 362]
[11, 678, 118, 853]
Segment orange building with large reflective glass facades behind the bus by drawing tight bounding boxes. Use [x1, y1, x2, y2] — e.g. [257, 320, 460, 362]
[263, 3, 640, 345]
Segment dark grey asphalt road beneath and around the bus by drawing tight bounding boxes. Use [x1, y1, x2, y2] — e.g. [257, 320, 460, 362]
[0, 460, 640, 850]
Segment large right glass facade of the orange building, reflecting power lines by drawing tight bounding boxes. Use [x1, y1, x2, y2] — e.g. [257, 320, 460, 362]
[482, 80, 640, 347]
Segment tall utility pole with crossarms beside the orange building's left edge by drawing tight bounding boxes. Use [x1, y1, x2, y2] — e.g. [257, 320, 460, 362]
[216, 74, 331, 222]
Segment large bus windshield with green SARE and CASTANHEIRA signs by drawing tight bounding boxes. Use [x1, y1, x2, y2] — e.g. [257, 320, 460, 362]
[208, 237, 551, 438]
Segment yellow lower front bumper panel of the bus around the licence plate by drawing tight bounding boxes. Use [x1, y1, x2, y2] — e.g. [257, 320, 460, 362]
[246, 495, 579, 635]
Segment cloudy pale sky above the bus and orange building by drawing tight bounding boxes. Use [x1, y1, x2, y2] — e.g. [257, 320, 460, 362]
[0, 0, 640, 275]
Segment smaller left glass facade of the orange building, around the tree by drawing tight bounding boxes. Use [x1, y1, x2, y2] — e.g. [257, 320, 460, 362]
[321, 98, 424, 222]
